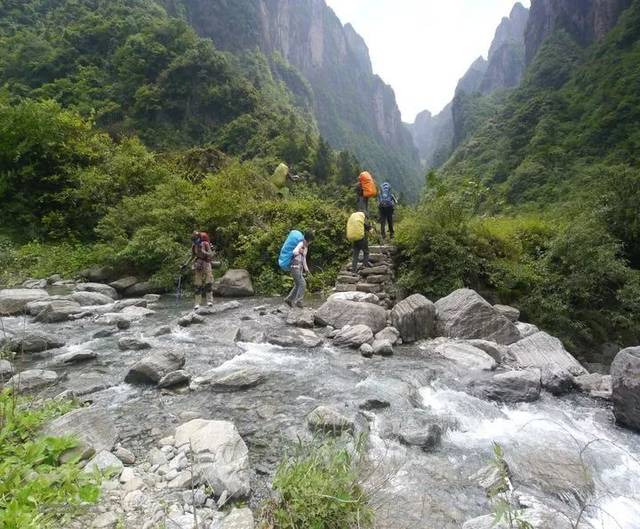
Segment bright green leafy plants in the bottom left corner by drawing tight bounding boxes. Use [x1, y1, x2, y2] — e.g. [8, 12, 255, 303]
[0, 391, 100, 529]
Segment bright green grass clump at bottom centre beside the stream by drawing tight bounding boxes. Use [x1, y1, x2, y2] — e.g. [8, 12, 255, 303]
[260, 441, 374, 529]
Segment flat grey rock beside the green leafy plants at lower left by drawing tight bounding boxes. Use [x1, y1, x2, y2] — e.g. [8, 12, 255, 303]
[42, 407, 118, 459]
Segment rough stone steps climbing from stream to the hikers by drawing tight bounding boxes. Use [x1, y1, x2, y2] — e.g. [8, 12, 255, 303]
[333, 245, 397, 309]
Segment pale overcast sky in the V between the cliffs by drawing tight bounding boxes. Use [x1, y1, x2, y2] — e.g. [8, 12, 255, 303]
[326, 0, 530, 122]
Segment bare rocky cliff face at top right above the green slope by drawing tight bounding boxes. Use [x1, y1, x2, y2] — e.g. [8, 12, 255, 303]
[525, 0, 633, 64]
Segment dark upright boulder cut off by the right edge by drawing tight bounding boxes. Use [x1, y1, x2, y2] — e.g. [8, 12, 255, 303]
[611, 347, 640, 431]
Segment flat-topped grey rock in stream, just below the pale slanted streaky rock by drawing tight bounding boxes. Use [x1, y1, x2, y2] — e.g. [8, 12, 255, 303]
[472, 369, 541, 402]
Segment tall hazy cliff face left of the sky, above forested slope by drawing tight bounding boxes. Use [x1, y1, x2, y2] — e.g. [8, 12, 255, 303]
[164, 0, 421, 196]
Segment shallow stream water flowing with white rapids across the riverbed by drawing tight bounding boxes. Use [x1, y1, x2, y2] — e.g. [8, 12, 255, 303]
[3, 297, 640, 529]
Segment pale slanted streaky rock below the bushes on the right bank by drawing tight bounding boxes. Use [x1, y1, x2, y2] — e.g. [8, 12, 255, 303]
[509, 332, 587, 380]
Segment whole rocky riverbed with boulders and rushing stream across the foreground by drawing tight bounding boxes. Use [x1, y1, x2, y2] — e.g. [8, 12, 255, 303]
[0, 282, 640, 529]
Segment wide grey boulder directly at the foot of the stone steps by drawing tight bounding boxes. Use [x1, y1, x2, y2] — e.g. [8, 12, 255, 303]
[316, 298, 387, 333]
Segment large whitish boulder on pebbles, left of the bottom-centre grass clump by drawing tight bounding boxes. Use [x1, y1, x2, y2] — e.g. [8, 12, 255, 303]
[174, 419, 251, 498]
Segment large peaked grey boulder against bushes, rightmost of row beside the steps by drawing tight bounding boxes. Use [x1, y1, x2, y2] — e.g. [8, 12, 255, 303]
[435, 288, 520, 345]
